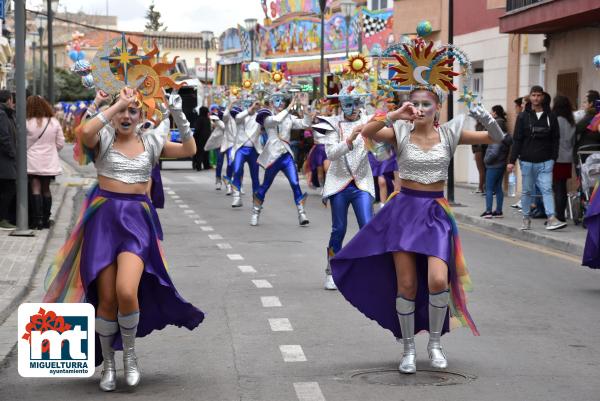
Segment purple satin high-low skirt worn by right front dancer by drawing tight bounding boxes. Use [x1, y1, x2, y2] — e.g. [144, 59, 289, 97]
[331, 188, 476, 338]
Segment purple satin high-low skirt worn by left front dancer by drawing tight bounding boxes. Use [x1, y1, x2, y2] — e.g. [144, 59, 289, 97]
[80, 189, 204, 364]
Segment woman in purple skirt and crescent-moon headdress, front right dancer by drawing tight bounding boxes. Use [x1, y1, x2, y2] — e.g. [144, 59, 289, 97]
[331, 38, 503, 373]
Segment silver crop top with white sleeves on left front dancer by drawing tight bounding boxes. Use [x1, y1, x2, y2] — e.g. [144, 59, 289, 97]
[94, 127, 165, 184]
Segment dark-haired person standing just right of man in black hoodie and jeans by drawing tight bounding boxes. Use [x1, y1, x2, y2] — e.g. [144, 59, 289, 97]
[552, 96, 575, 221]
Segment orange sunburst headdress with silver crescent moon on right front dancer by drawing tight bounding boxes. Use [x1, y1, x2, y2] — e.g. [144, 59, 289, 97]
[385, 25, 471, 101]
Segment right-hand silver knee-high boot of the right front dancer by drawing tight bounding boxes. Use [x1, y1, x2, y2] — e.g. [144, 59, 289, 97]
[427, 290, 450, 369]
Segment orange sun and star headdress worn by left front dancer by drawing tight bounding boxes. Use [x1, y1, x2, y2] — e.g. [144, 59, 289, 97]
[92, 34, 183, 125]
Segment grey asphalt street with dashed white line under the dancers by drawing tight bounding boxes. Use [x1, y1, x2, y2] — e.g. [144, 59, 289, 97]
[0, 164, 600, 401]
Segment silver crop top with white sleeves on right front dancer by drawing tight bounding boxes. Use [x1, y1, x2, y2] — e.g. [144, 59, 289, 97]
[394, 115, 466, 184]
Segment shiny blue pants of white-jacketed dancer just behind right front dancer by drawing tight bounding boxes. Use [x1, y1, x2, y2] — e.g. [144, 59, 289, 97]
[329, 181, 373, 255]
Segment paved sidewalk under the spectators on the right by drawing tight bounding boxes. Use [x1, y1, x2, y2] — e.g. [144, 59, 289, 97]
[453, 184, 587, 256]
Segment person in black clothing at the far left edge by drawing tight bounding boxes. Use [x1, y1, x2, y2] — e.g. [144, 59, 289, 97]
[0, 90, 17, 230]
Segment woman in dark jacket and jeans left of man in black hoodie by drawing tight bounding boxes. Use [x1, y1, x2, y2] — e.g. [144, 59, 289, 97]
[481, 105, 512, 219]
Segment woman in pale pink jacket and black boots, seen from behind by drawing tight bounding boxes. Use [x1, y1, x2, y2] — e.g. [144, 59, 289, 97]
[27, 96, 65, 230]
